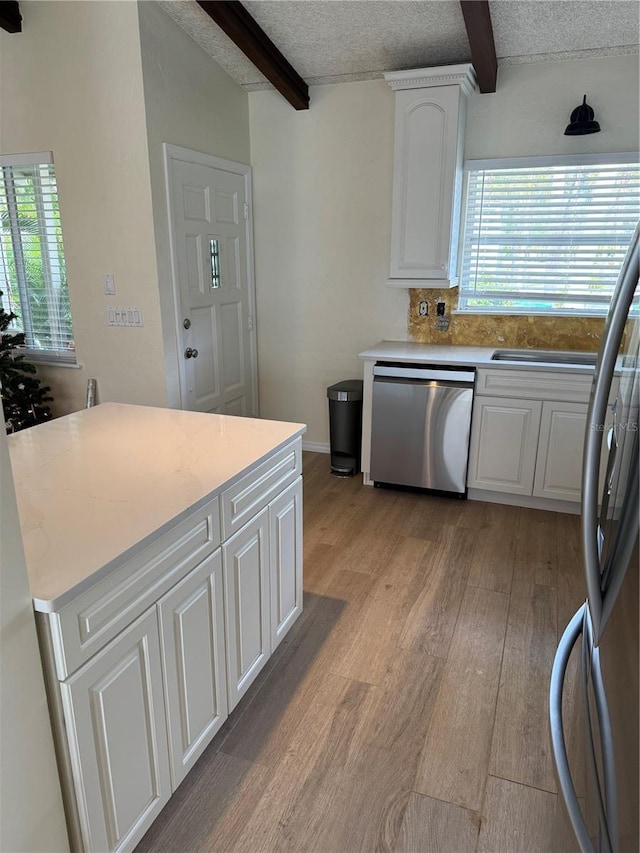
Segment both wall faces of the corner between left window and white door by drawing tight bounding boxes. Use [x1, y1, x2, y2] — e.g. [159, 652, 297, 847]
[0, 0, 250, 414]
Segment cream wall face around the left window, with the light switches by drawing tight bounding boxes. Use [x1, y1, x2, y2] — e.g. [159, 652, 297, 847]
[0, 0, 166, 412]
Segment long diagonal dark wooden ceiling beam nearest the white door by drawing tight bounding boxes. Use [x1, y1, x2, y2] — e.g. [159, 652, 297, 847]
[198, 0, 309, 110]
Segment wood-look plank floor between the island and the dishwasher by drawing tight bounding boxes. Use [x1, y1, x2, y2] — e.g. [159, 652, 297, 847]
[138, 453, 582, 853]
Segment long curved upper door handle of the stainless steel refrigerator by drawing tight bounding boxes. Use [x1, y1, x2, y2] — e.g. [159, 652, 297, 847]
[581, 224, 640, 643]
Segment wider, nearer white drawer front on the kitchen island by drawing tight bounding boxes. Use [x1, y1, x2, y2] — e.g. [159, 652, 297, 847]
[50, 498, 221, 680]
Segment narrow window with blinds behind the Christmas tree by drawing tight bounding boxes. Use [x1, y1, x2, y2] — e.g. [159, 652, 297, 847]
[0, 153, 76, 362]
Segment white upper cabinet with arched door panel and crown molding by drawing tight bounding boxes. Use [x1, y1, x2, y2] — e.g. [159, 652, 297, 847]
[385, 64, 476, 288]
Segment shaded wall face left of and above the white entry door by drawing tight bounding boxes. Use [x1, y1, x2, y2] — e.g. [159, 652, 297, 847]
[138, 2, 250, 407]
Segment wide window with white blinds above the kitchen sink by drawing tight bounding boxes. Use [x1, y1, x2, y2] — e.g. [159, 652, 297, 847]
[458, 156, 640, 315]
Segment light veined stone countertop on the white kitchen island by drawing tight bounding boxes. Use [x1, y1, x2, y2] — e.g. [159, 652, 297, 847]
[8, 403, 306, 611]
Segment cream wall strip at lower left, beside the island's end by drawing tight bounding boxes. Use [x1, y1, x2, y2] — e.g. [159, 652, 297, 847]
[0, 407, 69, 853]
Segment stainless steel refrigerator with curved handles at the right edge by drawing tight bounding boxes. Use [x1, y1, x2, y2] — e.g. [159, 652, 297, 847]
[549, 225, 640, 853]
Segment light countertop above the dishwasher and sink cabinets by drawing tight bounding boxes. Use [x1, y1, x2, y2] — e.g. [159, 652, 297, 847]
[359, 341, 594, 375]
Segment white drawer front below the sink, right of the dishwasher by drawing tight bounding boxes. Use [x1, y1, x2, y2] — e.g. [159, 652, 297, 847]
[476, 369, 593, 403]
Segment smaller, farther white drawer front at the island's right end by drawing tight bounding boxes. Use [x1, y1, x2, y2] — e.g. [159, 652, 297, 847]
[222, 439, 302, 539]
